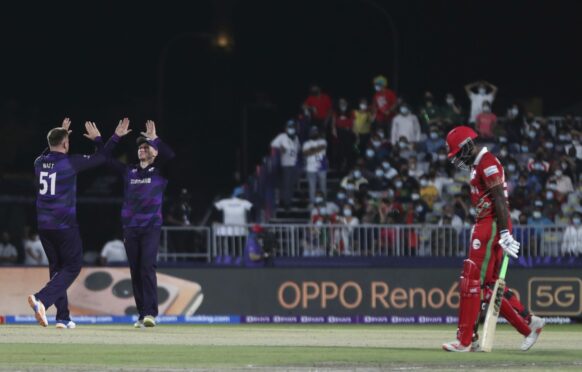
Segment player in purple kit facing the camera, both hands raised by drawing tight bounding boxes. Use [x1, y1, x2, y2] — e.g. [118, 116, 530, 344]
[109, 120, 175, 328]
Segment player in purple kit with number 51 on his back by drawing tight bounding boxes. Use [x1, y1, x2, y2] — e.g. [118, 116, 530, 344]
[28, 118, 129, 328]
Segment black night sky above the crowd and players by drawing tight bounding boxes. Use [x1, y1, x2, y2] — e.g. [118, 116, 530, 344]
[0, 0, 582, 215]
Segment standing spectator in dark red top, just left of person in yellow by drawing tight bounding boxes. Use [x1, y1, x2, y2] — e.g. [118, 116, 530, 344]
[332, 98, 356, 171]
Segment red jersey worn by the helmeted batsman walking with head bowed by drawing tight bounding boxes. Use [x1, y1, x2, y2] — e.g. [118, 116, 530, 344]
[469, 147, 510, 222]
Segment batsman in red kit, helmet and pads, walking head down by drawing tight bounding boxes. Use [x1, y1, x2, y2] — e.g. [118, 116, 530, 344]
[443, 126, 545, 352]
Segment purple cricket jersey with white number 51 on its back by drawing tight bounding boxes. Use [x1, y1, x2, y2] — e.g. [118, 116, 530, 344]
[34, 134, 119, 230]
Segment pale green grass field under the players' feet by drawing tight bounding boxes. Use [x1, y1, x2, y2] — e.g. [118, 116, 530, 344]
[0, 325, 582, 371]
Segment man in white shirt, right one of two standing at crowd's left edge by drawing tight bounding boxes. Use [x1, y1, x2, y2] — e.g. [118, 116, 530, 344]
[303, 127, 327, 205]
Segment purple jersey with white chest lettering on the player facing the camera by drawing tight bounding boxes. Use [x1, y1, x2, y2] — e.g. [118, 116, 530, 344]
[110, 138, 175, 227]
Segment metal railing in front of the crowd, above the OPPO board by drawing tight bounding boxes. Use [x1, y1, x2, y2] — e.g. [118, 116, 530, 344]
[160, 224, 582, 262]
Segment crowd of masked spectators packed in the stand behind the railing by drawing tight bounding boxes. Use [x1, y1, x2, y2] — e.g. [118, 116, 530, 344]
[271, 76, 582, 253]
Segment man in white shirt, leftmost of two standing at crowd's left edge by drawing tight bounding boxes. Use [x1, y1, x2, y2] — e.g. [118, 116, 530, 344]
[271, 119, 301, 209]
